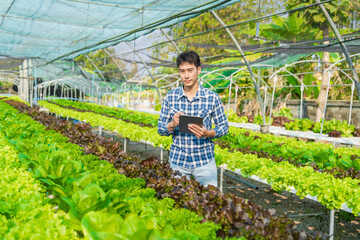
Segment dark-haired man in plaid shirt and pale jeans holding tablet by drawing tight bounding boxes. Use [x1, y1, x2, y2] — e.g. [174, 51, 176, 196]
[158, 51, 229, 187]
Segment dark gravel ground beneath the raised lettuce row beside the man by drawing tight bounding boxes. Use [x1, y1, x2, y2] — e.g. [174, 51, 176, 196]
[99, 132, 360, 240]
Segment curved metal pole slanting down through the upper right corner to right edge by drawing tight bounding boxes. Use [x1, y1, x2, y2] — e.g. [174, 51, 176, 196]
[315, 0, 360, 100]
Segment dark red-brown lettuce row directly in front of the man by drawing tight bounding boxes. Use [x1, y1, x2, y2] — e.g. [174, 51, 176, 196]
[3, 98, 320, 239]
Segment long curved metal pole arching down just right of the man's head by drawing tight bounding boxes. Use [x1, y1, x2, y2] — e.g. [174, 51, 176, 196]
[211, 11, 268, 125]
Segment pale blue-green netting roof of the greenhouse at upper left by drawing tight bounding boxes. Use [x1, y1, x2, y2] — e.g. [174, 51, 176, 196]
[0, 0, 238, 60]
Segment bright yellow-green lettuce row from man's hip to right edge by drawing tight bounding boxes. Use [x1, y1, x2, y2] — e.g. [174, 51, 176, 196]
[215, 146, 360, 215]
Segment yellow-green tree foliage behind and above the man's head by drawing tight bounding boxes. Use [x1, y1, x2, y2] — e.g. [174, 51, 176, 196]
[153, 0, 283, 63]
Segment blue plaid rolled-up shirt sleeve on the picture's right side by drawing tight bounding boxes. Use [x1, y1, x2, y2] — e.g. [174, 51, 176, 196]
[212, 96, 229, 138]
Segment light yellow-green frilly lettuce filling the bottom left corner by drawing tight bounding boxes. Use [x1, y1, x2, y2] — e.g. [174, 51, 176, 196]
[0, 133, 78, 239]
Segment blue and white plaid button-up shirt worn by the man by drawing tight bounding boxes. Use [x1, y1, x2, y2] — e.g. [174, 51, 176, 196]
[158, 85, 229, 169]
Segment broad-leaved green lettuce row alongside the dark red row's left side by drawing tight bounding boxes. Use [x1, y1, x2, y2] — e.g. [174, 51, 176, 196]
[0, 102, 219, 239]
